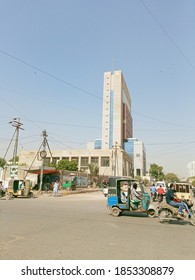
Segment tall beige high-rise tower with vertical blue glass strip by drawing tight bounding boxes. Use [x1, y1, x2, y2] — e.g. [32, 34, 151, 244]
[102, 71, 133, 149]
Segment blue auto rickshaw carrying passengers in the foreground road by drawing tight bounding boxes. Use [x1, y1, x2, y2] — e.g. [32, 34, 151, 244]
[107, 176, 156, 217]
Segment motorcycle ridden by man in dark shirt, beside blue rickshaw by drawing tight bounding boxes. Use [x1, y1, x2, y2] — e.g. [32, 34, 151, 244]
[158, 201, 195, 226]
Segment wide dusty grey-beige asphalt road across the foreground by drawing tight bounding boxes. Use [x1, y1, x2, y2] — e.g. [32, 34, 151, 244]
[0, 192, 195, 260]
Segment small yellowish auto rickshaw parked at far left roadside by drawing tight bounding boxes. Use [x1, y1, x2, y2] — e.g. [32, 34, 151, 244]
[7, 179, 34, 198]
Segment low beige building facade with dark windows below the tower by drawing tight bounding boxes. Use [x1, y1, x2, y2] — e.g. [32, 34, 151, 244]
[19, 147, 133, 176]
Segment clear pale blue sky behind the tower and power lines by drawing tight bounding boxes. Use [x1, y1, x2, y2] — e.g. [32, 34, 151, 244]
[0, 0, 195, 176]
